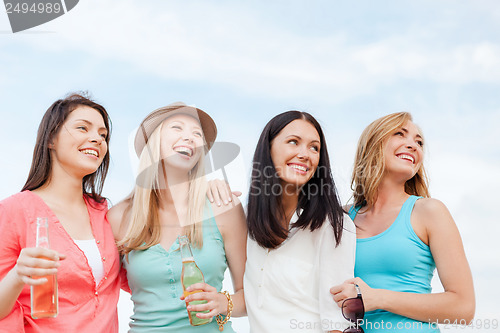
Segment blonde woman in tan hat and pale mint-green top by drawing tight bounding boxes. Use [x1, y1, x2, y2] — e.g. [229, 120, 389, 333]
[108, 103, 247, 333]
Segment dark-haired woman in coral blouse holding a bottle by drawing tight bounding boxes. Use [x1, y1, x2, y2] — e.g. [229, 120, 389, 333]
[0, 94, 120, 333]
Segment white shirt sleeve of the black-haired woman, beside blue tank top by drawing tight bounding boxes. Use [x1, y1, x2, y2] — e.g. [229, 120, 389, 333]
[318, 214, 356, 331]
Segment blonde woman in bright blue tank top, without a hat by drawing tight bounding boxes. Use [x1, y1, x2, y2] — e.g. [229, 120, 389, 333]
[331, 112, 475, 333]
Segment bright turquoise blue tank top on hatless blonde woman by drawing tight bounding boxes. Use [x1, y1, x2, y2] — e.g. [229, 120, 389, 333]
[349, 196, 439, 333]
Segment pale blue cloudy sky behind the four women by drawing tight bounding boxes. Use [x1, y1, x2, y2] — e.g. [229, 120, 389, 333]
[0, 0, 500, 332]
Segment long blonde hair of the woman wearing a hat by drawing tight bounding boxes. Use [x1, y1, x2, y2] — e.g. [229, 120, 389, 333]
[117, 123, 207, 254]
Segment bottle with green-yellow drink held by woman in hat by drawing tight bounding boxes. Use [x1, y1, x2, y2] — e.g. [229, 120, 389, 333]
[179, 236, 212, 326]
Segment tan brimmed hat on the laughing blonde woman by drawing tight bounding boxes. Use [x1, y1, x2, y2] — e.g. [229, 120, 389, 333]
[134, 102, 217, 156]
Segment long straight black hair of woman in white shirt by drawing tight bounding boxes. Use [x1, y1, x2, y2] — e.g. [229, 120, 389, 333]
[247, 111, 343, 249]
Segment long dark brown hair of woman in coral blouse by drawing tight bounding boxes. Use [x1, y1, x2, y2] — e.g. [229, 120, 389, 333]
[22, 94, 111, 202]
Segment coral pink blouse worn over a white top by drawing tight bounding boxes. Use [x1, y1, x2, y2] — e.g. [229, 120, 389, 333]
[0, 191, 120, 333]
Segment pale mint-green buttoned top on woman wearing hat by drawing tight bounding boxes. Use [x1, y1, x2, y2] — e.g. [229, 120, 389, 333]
[123, 206, 234, 333]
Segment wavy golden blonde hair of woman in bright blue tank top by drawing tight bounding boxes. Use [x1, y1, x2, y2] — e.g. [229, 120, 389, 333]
[351, 112, 430, 207]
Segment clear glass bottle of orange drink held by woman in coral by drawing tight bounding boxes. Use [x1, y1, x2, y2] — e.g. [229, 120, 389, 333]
[31, 217, 59, 319]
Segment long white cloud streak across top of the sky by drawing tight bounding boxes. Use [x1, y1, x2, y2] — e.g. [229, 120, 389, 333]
[13, 0, 500, 103]
